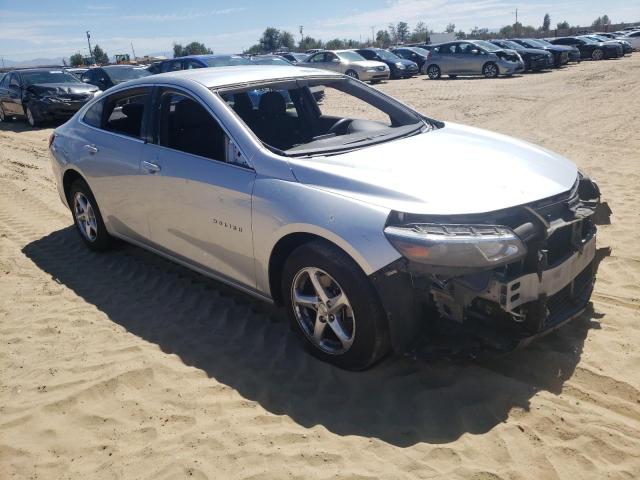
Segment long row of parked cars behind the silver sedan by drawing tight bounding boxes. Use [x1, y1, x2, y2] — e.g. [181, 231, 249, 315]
[0, 29, 640, 127]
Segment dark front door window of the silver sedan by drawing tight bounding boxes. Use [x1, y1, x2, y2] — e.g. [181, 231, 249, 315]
[158, 92, 227, 162]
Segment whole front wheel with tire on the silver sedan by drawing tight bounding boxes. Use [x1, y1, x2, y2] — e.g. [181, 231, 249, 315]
[282, 240, 390, 370]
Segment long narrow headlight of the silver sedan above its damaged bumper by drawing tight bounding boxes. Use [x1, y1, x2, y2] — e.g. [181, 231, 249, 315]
[384, 224, 527, 268]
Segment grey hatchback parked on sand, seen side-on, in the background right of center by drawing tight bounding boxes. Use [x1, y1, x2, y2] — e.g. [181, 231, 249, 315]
[427, 40, 524, 80]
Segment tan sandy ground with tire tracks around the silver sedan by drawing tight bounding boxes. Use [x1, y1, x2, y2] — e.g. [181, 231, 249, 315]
[0, 53, 640, 480]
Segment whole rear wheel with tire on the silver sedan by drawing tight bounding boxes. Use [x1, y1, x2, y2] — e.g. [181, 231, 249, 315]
[69, 179, 113, 252]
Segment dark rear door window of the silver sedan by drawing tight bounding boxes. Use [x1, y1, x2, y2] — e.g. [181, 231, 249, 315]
[102, 88, 149, 138]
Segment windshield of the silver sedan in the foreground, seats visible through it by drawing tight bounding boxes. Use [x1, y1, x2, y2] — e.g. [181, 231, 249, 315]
[219, 78, 431, 156]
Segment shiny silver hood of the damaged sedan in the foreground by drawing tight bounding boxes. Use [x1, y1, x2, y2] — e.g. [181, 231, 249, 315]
[289, 123, 578, 215]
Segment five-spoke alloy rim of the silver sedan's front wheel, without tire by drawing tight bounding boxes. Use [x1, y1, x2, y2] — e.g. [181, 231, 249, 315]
[291, 267, 356, 355]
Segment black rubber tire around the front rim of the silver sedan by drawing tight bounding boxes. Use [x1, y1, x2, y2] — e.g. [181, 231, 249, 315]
[282, 240, 390, 370]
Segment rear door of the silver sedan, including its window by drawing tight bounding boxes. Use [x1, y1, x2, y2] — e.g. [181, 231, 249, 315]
[74, 87, 151, 242]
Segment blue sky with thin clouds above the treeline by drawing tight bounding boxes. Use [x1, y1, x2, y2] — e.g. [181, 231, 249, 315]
[0, 0, 640, 60]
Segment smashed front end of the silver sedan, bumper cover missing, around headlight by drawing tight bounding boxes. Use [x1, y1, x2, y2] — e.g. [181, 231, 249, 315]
[372, 175, 602, 351]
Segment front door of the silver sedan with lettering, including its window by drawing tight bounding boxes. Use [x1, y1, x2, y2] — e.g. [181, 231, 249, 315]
[141, 88, 255, 288]
